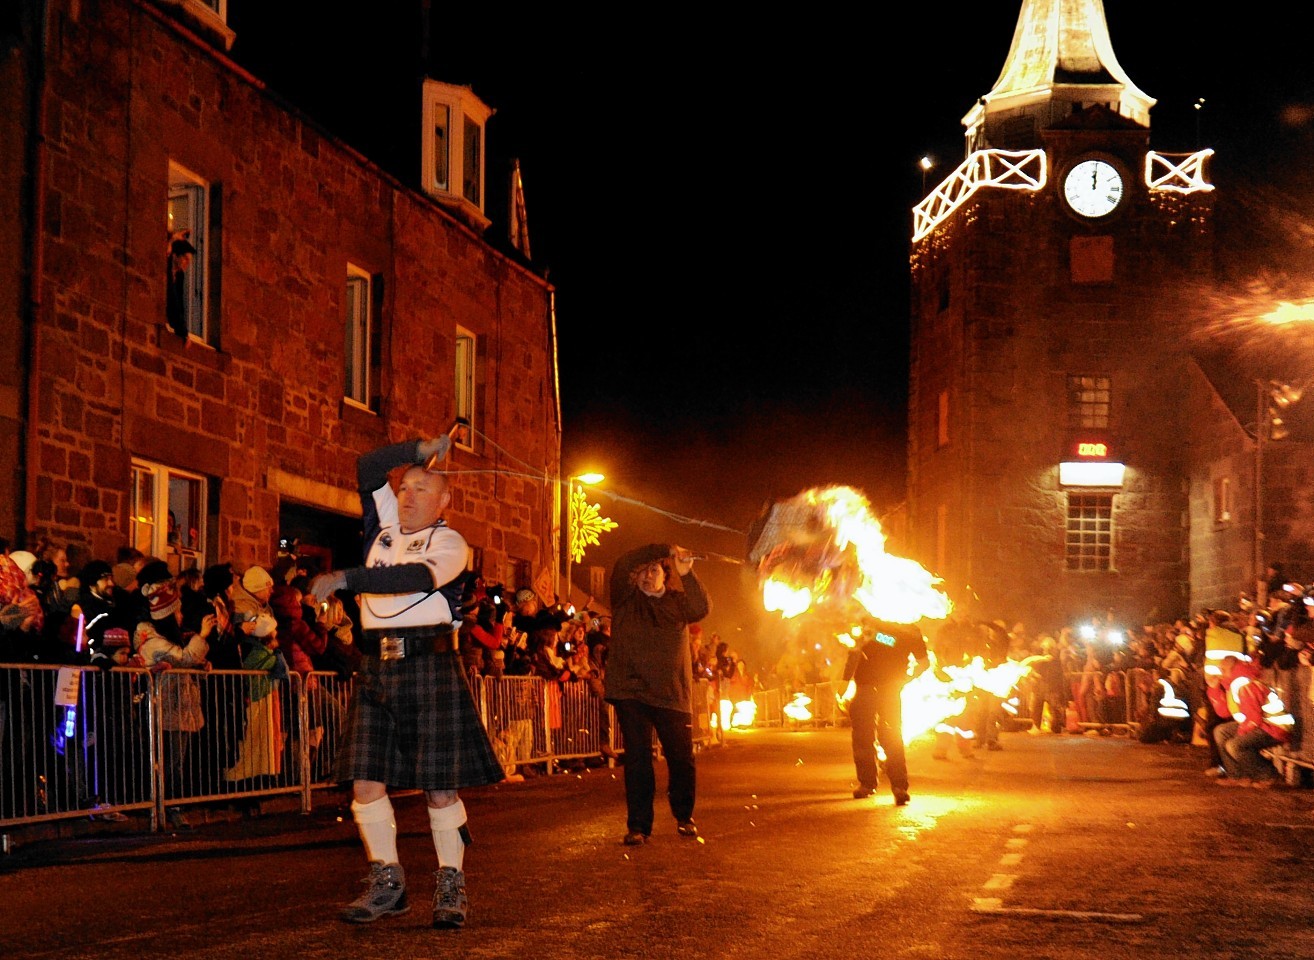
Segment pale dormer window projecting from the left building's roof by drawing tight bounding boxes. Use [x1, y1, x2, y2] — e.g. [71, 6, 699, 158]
[420, 80, 493, 230]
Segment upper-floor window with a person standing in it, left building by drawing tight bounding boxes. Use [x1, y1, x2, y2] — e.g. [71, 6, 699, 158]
[164, 163, 214, 344]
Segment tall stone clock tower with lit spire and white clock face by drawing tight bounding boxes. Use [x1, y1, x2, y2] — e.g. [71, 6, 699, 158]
[905, 0, 1213, 632]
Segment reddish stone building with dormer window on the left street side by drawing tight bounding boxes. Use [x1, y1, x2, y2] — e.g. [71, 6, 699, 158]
[0, 0, 560, 586]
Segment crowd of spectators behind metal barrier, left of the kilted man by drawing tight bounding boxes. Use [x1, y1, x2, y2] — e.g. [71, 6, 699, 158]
[0, 542, 373, 827]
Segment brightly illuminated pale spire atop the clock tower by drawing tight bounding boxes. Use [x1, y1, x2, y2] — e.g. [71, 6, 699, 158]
[963, 0, 1155, 155]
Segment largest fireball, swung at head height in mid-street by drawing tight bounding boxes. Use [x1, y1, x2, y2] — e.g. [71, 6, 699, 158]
[749, 486, 953, 624]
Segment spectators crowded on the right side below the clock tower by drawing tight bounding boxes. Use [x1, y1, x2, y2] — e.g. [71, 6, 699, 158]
[741, 579, 1314, 788]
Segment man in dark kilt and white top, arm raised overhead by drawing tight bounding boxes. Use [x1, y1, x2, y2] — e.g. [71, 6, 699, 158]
[313, 436, 503, 927]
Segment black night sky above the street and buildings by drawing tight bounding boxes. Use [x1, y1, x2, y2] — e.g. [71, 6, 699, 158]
[230, 0, 1314, 556]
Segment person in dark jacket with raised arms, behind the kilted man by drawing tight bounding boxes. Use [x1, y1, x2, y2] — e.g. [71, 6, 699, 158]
[603, 544, 711, 846]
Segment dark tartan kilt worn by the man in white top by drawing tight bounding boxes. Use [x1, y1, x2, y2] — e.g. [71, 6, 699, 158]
[334, 651, 506, 791]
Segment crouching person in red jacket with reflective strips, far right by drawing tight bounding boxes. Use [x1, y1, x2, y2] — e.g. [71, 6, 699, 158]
[1208, 654, 1294, 789]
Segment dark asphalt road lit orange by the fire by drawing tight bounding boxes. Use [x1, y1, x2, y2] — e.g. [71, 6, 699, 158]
[0, 729, 1314, 960]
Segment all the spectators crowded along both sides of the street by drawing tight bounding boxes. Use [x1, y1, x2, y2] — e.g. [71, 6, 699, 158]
[0, 533, 1314, 819]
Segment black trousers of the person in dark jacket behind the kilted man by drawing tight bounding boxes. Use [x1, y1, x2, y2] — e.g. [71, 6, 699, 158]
[615, 700, 694, 835]
